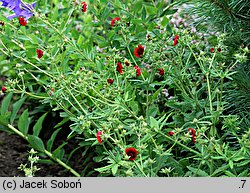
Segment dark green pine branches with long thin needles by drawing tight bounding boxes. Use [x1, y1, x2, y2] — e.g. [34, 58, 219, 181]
[178, 0, 250, 130]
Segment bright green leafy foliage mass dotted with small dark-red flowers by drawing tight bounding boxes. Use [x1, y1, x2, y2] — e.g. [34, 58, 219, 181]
[0, 0, 250, 177]
